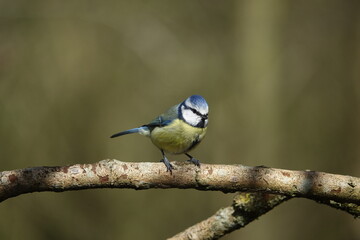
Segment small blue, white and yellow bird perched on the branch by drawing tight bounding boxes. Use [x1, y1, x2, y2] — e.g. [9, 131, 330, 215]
[111, 95, 209, 173]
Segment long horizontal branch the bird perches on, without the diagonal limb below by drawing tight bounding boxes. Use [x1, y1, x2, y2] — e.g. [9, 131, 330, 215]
[0, 160, 360, 205]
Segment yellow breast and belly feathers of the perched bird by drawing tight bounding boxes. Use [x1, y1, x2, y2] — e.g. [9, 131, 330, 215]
[150, 119, 206, 154]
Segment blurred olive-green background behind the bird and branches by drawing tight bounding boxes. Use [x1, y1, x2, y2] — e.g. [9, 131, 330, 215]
[0, 0, 360, 240]
